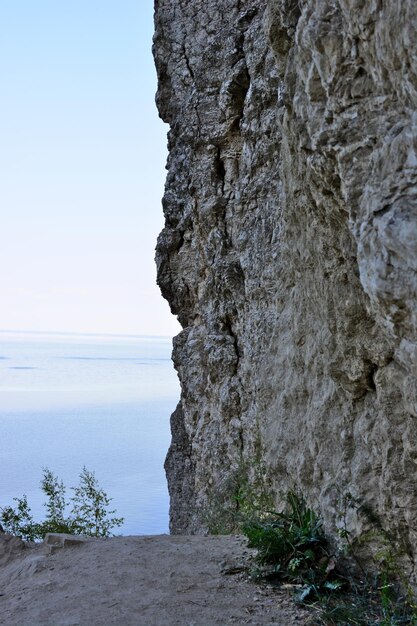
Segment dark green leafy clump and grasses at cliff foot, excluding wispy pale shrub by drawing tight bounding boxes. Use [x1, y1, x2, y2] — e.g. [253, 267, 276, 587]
[241, 491, 417, 626]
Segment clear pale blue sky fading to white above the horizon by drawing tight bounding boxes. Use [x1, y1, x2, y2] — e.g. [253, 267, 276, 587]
[0, 0, 180, 336]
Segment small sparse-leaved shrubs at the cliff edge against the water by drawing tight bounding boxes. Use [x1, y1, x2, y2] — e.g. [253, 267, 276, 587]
[0, 467, 124, 541]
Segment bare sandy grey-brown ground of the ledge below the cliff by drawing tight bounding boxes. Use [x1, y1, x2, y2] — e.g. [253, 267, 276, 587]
[0, 534, 308, 626]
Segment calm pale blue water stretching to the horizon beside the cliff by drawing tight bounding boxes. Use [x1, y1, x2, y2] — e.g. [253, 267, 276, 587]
[0, 332, 179, 535]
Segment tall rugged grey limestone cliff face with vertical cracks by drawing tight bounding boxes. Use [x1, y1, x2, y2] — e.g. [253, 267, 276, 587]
[154, 0, 417, 572]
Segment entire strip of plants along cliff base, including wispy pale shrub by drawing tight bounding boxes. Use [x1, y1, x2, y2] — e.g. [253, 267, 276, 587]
[201, 462, 417, 626]
